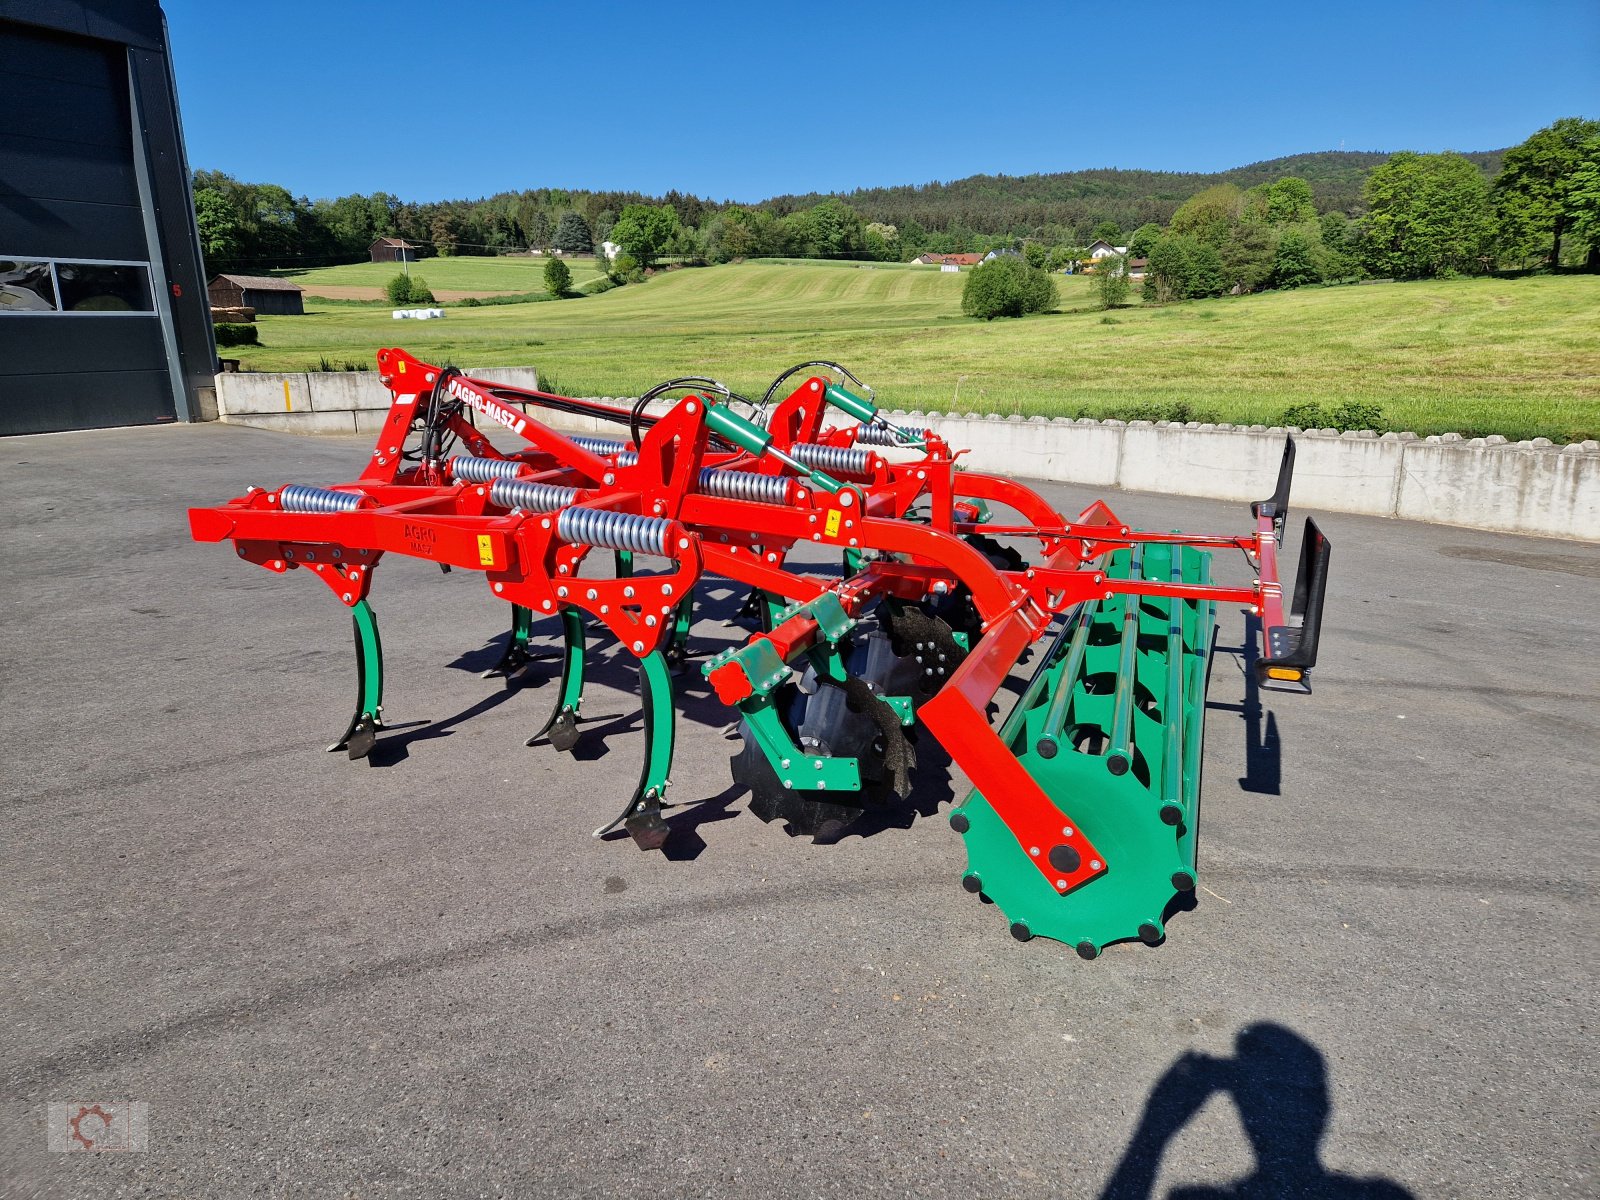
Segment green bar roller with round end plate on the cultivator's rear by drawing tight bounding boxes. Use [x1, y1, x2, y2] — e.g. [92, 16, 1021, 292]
[950, 544, 1213, 958]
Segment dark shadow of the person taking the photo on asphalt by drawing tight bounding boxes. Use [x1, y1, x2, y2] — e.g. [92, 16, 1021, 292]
[1101, 1022, 1411, 1200]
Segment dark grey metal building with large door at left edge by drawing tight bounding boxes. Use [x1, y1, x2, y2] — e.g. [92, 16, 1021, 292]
[0, 0, 216, 434]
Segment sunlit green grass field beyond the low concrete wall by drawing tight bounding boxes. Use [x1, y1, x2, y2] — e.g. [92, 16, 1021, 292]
[230, 259, 1600, 442]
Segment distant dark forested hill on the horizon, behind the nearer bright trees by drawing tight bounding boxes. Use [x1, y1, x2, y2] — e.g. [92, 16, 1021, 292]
[780, 150, 1506, 234]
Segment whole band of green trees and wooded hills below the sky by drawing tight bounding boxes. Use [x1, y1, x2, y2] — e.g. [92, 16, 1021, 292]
[194, 118, 1600, 281]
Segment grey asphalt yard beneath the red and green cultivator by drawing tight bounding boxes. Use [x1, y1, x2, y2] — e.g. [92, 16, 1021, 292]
[0, 426, 1600, 1200]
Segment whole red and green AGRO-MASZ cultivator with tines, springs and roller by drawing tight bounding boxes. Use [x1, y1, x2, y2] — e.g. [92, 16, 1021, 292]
[190, 349, 1330, 957]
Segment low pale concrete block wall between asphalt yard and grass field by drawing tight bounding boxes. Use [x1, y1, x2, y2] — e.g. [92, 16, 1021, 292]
[216, 366, 1600, 541]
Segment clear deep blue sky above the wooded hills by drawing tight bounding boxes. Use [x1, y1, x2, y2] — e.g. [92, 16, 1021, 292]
[165, 0, 1600, 200]
